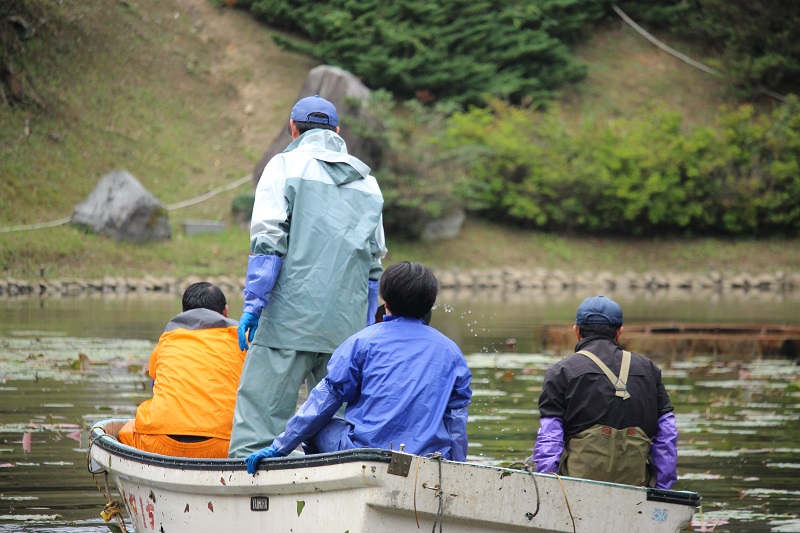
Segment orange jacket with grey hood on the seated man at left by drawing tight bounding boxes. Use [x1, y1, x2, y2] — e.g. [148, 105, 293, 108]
[135, 309, 246, 439]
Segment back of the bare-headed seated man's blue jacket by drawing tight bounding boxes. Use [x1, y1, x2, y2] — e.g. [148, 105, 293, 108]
[327, 316, 472, 460]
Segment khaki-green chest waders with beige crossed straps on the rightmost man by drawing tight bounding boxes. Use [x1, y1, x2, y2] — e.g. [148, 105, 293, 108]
[559, 350, 650, 486]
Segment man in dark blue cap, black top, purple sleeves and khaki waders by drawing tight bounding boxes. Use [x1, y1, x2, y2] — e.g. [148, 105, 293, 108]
[531, 296, 678, 489]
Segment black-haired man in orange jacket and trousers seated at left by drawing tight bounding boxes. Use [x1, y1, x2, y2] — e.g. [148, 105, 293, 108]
[119, 282, 246, 458]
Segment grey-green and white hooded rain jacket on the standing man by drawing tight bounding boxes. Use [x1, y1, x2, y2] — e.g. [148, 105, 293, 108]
[251, 129, 384, 353]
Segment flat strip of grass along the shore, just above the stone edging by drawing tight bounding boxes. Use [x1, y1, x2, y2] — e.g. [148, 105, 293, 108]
[0, 217, 800, 280]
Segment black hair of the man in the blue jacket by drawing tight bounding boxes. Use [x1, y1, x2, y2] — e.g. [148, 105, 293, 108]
[380, 261, 439, 318]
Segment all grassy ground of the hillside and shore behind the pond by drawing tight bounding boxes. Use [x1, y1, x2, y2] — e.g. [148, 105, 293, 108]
[0, 0, 800, 279]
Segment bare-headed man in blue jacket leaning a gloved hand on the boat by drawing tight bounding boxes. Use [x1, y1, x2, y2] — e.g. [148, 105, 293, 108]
[246, 261, 472, 474]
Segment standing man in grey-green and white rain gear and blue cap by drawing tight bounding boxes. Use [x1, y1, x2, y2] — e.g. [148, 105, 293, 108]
[228, 96, 386, 457]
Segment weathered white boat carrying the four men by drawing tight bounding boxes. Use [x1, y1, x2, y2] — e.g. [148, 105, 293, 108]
[89, 419, 700, 533]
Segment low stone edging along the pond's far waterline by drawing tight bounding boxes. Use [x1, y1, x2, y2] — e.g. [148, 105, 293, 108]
[0, 268, 800, 297]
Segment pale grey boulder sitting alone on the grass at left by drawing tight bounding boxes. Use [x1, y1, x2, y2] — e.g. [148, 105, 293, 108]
[72, 170, 172, 242]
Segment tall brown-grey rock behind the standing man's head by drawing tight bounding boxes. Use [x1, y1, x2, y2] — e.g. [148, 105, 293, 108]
[253, 65, 385, 184]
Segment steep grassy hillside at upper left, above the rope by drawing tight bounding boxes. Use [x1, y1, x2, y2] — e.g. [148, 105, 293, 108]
[0, 0, 314, 226]
